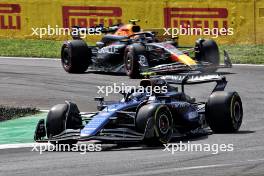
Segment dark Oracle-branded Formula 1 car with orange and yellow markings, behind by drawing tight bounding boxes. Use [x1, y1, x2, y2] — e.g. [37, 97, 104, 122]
[61, 20, 232, 78]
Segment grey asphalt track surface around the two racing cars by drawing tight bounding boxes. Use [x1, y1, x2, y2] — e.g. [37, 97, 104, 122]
[0, 59, 264, 176]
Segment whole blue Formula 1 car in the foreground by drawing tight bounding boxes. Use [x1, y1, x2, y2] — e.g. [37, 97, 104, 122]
[35, 75, 243, 145]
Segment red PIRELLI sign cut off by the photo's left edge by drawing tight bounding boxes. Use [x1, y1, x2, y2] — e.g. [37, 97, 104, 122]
[0, 4, 21, 30]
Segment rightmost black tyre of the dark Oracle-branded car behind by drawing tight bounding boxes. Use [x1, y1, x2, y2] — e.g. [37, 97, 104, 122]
[195, 39, 220, 72]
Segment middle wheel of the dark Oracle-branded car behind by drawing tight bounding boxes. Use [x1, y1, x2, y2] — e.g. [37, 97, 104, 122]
[124, 45, 145, 79]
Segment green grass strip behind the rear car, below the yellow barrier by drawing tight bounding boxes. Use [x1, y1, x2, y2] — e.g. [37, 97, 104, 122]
[0, 39, 264, 64]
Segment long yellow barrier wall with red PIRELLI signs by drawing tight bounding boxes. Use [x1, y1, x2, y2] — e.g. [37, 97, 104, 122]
[0, 0, 264, 45]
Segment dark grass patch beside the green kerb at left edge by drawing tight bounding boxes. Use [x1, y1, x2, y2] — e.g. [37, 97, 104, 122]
[0, 105, 40, 122]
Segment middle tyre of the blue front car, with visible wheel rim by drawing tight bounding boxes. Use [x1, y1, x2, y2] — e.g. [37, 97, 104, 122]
[136, 105, 173, 146]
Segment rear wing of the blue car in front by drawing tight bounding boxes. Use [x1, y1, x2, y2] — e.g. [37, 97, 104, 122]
[159, 74, 227, 92]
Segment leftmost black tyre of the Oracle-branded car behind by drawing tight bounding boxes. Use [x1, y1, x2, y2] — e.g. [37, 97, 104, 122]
[61, 40, 91, 73]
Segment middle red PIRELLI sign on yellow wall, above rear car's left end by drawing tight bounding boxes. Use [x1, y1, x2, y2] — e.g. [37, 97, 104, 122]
[62, 6, 122, 28]
